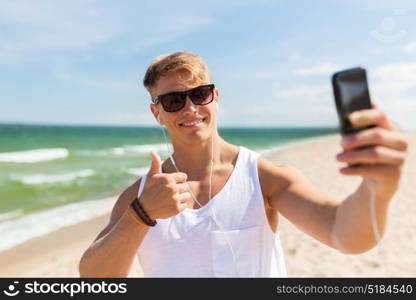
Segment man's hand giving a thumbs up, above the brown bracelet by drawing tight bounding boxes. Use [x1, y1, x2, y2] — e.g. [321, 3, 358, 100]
[139, 152, 192, 220]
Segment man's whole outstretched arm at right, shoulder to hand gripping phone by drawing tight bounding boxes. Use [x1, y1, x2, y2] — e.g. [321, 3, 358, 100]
[259, 103, 408, 254]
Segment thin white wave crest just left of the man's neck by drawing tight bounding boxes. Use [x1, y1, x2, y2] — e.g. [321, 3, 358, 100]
[77, 144, 172, 156]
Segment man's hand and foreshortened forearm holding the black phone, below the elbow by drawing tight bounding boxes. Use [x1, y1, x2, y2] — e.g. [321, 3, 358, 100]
[332, 105, 408, 253]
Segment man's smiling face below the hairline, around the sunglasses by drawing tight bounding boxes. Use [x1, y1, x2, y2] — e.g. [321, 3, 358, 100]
[150, 73, 218, 143]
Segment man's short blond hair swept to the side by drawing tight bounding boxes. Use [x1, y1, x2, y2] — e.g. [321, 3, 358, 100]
[143, 51, 211, 94]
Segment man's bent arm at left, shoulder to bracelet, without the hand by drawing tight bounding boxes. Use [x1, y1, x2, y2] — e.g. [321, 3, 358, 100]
[79, 179, 149, 277]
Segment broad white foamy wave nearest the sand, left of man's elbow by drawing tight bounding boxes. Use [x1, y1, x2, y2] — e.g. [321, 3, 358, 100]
[0, 197, 117, 251]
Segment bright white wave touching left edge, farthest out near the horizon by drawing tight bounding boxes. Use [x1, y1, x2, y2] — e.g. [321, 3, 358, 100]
[0, 148, 68, 163]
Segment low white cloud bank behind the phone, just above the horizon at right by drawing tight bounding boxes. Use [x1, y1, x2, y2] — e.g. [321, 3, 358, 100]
[270, 61, 416, 130]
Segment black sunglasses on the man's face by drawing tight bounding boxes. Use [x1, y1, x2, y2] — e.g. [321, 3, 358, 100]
[152, 83, 215, 112]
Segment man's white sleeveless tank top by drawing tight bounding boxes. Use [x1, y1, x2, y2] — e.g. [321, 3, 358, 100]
[138, 146, 287, 277]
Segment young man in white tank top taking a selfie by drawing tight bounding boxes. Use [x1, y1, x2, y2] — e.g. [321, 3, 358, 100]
[80, 52, 408, 277]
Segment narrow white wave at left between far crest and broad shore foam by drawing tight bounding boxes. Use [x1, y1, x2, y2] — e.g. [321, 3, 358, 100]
[10, 169, 94, 184]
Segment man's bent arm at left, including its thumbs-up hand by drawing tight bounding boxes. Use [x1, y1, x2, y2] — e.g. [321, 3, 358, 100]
[79, 152, 192, 277]
